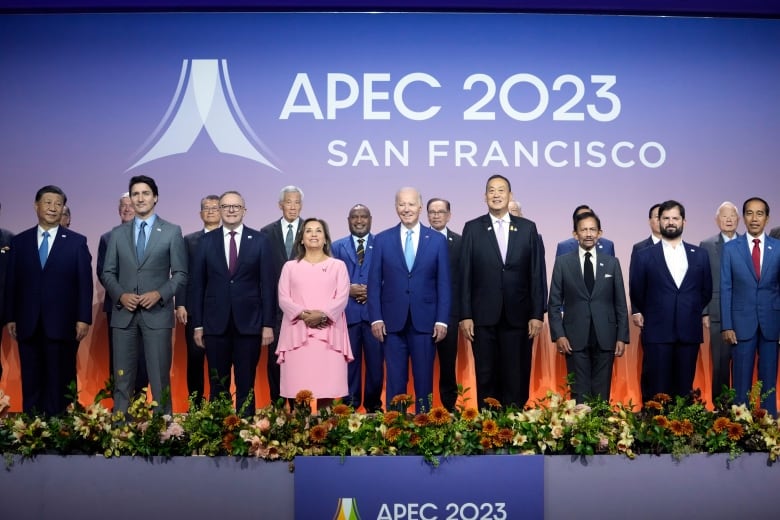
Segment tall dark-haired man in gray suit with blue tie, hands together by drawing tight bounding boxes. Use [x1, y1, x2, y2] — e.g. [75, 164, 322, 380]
[101, 175, 187, 413]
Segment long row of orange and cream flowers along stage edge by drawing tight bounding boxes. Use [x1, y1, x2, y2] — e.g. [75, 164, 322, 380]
[0, 384, 780, 465]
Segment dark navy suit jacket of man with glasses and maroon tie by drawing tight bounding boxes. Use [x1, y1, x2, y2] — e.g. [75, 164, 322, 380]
[188, 226, 277, 335]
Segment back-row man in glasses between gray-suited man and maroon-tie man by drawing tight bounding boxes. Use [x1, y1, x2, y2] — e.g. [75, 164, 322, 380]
[175, 195, 221, 401]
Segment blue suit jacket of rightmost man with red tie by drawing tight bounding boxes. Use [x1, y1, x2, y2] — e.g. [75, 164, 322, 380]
[720, 234, 780, 341]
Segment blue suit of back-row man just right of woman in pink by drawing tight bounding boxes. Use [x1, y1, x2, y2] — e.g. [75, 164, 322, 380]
[332, 233, 385, 412]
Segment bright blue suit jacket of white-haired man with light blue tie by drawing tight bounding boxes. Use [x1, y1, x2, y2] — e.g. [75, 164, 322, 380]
[368, 223, 451, 334]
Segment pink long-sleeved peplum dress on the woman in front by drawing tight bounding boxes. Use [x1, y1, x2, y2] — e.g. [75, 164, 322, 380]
[276, 258, 353, 399]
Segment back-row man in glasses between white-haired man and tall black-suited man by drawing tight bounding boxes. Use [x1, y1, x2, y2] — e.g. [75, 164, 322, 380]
[426, 199, 461, 412]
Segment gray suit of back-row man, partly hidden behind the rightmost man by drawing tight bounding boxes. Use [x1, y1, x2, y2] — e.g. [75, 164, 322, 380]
[699, 233, 737, 402]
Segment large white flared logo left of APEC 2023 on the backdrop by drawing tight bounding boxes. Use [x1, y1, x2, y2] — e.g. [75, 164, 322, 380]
[126, 59, 281, 171]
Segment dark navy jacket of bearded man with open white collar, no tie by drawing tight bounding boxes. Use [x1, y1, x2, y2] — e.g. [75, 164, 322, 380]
[629, 241, 712, 343]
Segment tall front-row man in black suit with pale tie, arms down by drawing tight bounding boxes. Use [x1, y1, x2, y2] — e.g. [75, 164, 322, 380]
[460, 175, 546, 407]
